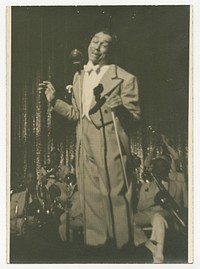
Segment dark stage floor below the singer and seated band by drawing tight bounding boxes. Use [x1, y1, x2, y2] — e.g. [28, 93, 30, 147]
[10, 221, 187, 264]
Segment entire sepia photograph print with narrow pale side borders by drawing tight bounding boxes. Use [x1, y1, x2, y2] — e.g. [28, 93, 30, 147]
[6, 5, 193, 264]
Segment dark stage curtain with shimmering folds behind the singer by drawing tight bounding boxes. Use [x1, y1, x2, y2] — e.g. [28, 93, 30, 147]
[11, 6, 189, 186]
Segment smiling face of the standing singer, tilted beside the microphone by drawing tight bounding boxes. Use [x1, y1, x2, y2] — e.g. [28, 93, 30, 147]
[88, 32, 112, 65]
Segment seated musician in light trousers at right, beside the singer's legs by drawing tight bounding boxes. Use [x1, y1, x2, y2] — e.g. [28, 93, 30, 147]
[133, 158, 188, 263]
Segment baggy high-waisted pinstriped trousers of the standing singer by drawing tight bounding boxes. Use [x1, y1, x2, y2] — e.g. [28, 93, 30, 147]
[78, 117, 132, 248]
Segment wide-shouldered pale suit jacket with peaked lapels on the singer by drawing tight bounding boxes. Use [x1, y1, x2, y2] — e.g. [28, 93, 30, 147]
[54, 64, 140, 161]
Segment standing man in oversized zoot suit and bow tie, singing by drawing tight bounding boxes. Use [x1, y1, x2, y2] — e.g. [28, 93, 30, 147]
[40, 29, 140, 248]
